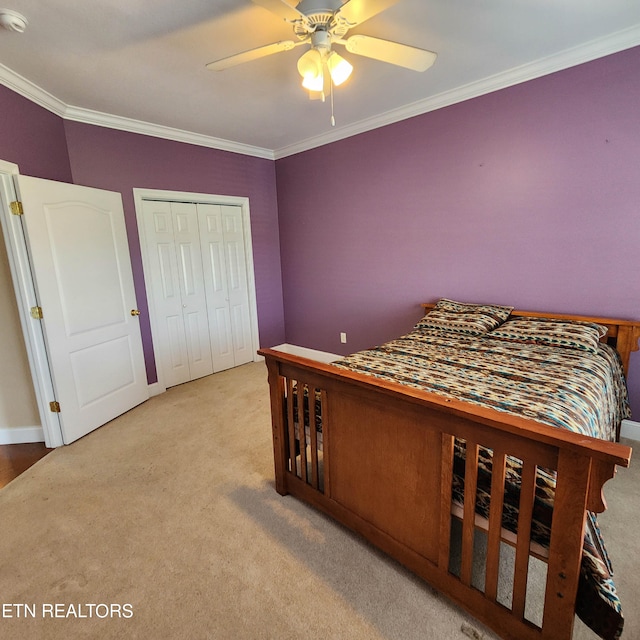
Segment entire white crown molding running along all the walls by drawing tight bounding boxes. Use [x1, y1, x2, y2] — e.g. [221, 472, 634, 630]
[0, 25, 640, 165]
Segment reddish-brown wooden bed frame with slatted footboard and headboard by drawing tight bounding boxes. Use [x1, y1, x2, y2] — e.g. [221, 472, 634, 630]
[259, 304, 640, 640]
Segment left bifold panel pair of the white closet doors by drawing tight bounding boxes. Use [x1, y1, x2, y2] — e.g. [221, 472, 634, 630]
[143, 200, 213, 387]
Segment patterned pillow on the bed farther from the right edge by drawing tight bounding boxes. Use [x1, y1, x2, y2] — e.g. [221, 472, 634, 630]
[415, 298, 513, 336]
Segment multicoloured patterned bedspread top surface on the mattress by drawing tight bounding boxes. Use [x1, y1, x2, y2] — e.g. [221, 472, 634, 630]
[333, 330, 630, 440]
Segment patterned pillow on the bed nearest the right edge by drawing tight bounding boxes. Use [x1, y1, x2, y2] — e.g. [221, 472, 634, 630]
[487, 318, 607, 353]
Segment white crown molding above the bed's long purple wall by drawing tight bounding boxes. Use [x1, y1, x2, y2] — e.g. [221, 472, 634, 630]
[274, 25, 640, 160]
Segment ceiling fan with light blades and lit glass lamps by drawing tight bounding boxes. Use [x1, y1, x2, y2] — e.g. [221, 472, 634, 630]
[206, 0, 436, 100]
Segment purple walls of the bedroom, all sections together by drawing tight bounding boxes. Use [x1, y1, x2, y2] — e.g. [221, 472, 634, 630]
[0, 48, 640, 420]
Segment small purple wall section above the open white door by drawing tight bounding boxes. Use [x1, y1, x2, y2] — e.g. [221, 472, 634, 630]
[0, 85, 71, 182]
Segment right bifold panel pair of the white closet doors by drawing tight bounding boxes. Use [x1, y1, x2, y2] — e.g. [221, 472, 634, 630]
[198, 204, 253, 371]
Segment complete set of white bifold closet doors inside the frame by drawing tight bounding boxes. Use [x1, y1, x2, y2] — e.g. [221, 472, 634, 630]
[144, 200, 253, 387]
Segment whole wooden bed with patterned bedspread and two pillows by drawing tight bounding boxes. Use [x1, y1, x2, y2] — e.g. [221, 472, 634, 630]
[259, 299, 640, 640]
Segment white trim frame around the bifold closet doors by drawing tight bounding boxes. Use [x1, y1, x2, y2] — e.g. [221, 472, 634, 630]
[133, 189, 260, 394]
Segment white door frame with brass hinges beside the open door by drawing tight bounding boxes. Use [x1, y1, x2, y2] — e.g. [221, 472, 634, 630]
[0, 160, 64, 448]
